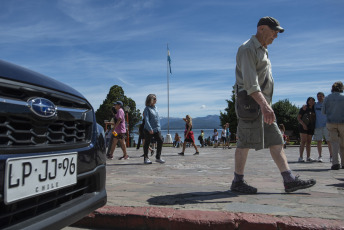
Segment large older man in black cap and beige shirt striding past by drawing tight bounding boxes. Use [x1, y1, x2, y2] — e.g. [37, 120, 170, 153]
[231, 17, 316, 194]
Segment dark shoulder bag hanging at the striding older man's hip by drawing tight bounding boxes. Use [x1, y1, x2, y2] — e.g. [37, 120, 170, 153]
[236, 76, 268, 121]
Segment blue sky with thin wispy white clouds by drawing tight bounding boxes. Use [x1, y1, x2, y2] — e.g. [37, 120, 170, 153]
[0, 0, 344, 117]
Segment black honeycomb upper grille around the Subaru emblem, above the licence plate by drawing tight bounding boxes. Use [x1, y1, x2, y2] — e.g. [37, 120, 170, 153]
[0, 78, 94, 153]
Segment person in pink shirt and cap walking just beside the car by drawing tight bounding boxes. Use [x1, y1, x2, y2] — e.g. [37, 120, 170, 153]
[106, 101, 129, 160]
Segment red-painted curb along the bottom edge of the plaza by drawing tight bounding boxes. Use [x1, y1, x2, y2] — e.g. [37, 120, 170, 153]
[74, 206, 344, 230]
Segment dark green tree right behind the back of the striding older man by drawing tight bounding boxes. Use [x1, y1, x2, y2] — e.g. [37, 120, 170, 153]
[220, 86, 238, 140]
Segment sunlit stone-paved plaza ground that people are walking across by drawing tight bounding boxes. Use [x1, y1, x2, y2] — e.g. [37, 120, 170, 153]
[106, 147, 344, 220]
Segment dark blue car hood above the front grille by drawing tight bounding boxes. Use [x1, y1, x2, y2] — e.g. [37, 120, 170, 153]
[0, 60, 85, 99]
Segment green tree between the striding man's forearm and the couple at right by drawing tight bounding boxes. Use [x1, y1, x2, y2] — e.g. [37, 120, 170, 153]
[272, 99, 299, 137]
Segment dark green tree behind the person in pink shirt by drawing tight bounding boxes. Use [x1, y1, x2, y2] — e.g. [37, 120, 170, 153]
[96, 85, 142, 137]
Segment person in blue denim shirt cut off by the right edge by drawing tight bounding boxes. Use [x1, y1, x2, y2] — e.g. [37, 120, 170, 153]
[322, 81, 344, 170]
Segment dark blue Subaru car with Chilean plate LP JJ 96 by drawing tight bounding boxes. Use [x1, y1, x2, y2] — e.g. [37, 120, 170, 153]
[0, 61, 107, 229]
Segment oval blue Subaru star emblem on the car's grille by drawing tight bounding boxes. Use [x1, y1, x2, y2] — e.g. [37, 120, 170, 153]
[28, 97, 56, 118]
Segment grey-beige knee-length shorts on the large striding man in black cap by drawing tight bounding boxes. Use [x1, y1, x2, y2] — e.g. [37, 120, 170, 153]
[237, 115, 284, 150]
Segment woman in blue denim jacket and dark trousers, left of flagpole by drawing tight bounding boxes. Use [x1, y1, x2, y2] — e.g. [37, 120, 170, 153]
[143, 94, 165, 164]
